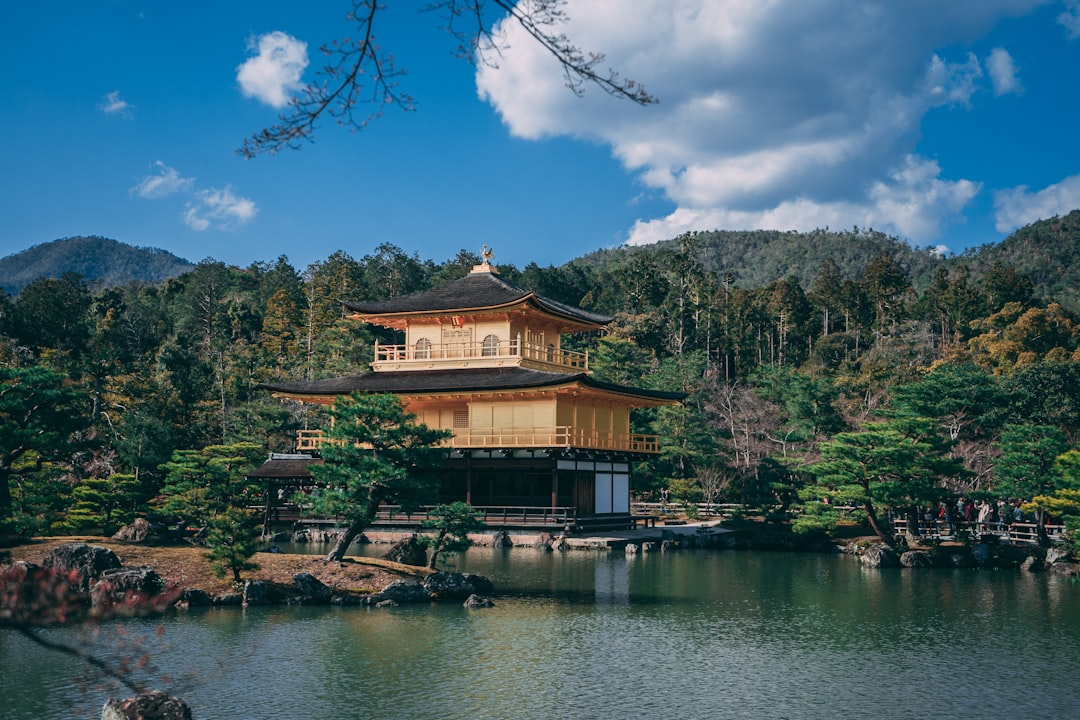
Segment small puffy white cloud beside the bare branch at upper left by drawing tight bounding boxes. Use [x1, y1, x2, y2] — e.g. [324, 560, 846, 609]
[237, 30, 308, 108]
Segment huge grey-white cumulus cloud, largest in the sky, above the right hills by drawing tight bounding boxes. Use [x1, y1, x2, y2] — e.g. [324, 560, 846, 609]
[476, 0, 1042, 244]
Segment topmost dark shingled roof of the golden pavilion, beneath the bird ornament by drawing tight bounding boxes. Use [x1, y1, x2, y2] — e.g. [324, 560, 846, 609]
[345, 272, 615, 325]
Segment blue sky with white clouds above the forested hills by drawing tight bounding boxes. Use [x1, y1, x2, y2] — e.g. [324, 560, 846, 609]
[0, 0, 1080, 274]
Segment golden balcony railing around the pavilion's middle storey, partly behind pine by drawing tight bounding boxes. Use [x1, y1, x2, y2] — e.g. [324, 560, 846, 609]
[296, 425, 660, 454]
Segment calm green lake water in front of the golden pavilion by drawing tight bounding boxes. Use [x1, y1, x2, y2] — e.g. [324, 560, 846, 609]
[0, 546, 1080, 720]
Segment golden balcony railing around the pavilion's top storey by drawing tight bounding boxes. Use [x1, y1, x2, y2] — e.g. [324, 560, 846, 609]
[375, 340, 589, 370]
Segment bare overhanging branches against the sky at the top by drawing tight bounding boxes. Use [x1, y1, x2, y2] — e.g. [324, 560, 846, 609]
[237, 0, 657, 158]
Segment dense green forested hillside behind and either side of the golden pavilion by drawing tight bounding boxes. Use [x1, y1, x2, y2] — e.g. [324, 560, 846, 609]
[0, 220, 1080, 546]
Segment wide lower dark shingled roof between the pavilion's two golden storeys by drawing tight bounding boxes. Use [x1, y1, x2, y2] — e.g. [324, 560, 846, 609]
[259, 367, 686, 400]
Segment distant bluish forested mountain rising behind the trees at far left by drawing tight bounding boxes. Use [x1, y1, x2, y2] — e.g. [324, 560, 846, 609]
[0, 236, 192, 295]
